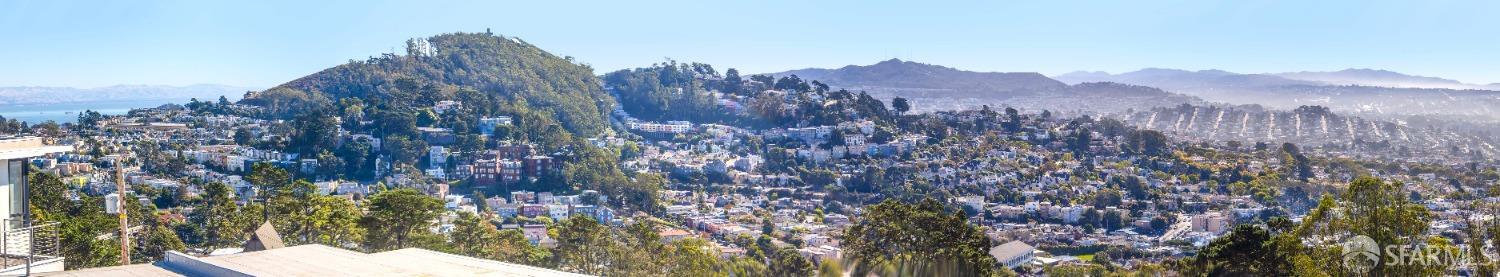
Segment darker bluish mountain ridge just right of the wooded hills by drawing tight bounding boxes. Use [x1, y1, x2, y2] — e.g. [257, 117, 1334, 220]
[770, 58, 1202, 112]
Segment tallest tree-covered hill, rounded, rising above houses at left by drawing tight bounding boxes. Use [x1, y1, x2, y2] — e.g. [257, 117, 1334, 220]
[243, 31, 614, 135]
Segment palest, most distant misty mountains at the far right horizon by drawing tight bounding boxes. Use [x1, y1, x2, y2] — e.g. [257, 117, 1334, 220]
[1053, 69, 1500, 121]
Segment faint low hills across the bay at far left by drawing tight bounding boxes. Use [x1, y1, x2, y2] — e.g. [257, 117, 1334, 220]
[0, 84, 255, 105]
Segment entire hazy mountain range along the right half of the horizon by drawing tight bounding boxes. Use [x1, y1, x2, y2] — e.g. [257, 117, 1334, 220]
[771, 58, 1500, 121]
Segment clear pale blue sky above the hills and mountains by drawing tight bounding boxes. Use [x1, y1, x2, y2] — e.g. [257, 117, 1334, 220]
[0, 0, 1500, 87]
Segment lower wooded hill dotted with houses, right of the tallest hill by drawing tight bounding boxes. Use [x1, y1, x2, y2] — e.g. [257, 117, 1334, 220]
[603, 60, 893, 127]
